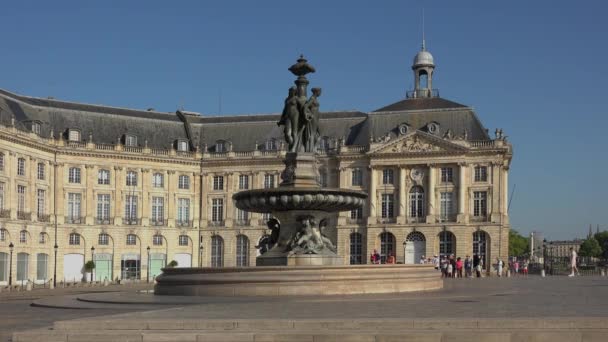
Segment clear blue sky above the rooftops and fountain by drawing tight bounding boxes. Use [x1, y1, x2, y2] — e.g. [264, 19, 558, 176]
[0, 0, 608, 239]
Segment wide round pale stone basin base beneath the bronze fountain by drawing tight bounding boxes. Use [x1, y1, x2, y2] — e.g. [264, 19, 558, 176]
[154, 265, 443, 296]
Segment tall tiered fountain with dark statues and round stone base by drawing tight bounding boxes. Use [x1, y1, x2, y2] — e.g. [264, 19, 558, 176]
[154, 56, 443, 296]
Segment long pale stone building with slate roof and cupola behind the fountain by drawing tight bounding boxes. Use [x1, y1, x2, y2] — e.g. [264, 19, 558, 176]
[0, 48, 512, 284]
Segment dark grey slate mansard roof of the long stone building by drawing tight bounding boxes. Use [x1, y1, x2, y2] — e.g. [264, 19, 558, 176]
[0, 89, 489, 151]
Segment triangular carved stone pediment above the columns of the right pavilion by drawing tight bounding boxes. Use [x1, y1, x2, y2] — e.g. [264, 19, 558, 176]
[369, 132, 466, 154]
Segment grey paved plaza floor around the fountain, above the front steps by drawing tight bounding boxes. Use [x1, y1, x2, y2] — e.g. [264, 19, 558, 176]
[0, 276, 608, 341]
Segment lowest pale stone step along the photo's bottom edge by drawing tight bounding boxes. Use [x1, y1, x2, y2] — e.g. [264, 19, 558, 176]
[13, 329, 608, 342]
